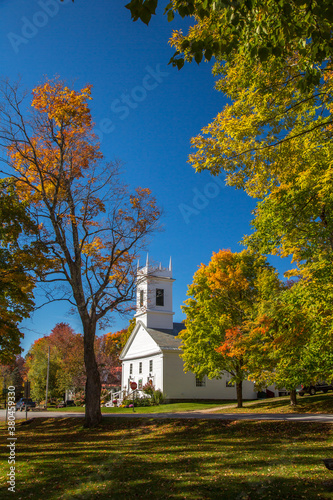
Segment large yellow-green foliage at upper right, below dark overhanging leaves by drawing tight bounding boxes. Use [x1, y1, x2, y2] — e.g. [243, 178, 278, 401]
[184, 53, 333, 281]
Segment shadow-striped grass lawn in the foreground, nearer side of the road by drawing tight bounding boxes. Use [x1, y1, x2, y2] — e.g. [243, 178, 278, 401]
[0, 417, 333, 500]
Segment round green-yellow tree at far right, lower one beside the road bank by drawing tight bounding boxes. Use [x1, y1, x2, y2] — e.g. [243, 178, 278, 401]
[246, 280, 333, 405]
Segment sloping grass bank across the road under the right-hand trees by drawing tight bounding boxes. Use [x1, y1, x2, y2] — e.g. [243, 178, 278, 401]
[213, 393, 333, 413]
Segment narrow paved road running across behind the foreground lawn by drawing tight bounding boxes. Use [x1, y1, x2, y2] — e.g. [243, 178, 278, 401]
[0, 410, 333, 423]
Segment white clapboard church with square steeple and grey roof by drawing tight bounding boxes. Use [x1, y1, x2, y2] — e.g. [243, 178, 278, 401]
[120, 256, 272, 401]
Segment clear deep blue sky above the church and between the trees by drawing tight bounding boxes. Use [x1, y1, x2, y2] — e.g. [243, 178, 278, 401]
[0, 0, 288, 349]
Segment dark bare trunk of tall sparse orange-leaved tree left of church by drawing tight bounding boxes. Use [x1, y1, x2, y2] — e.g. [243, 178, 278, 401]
[84, 327, 102, 427]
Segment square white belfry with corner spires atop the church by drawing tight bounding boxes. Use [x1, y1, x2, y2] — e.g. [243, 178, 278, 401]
[135, 255, 175, 330]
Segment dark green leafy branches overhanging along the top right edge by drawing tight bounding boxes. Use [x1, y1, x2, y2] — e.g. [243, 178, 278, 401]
[126, 0, 333, 88]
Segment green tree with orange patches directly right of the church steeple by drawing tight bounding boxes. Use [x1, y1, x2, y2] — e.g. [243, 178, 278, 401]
[179, 250, 278, 407]
